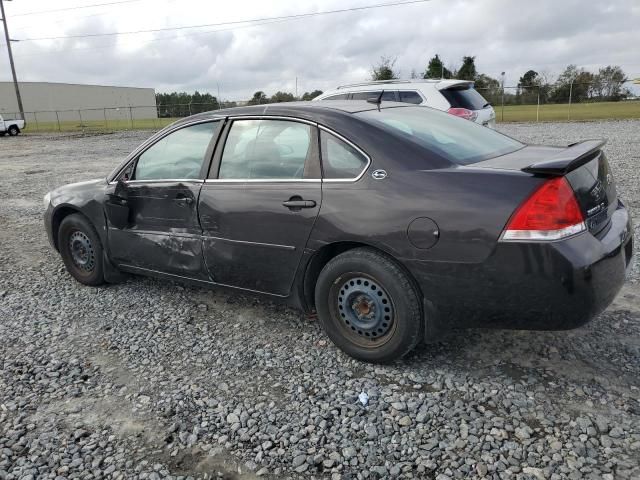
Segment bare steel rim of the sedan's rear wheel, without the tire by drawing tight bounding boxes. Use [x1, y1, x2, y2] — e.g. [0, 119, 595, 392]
[338, 277, 394, 340]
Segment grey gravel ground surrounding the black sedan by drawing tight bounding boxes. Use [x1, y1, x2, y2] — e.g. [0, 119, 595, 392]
[0, 121, 640, 480]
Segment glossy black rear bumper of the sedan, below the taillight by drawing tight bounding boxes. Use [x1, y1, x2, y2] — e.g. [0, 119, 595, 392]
[406, 204, 633, 330]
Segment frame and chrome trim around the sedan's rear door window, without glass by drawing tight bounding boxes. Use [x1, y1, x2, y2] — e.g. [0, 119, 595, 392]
[204, 115, 322, 183]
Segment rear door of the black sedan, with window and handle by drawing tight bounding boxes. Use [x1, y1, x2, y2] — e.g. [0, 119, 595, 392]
[199, 118, 322, 296]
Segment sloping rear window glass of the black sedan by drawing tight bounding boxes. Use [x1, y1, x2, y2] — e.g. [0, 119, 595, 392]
[355, 107, 524, 165]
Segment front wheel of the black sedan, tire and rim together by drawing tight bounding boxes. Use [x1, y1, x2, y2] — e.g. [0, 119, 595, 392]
[58, 213, 104, 286]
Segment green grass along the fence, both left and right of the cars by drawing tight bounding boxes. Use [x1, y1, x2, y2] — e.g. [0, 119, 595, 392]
[20, 100, 640, 133]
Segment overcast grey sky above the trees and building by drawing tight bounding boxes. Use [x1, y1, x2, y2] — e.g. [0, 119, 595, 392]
[0, 0, 640, 100]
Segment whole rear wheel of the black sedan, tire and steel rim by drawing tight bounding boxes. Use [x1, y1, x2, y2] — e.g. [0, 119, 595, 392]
[315, 248, 424, 363]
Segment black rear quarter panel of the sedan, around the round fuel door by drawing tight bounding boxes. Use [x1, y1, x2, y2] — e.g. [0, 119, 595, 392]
[309, 166, 541, 268]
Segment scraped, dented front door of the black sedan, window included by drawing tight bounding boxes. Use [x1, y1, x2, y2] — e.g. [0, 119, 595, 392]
[107, 121, 220, 280]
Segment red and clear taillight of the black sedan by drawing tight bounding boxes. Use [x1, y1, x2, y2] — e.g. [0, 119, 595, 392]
[500, 177, 586, 242]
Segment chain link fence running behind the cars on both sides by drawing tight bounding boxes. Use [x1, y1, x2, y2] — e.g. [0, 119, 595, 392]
[0, 82, 640, 132]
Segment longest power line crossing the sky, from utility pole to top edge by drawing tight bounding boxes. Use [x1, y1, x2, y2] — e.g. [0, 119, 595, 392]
[15, 0, 431, 42]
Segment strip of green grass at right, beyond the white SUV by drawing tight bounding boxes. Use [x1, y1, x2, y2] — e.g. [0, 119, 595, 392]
[500, 100, 640, 122]
